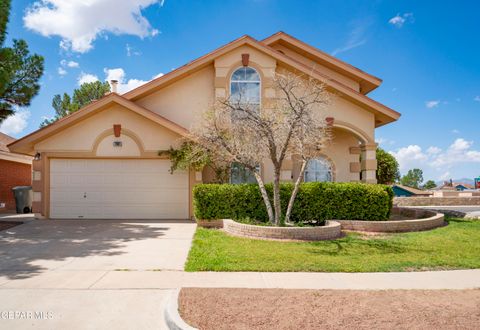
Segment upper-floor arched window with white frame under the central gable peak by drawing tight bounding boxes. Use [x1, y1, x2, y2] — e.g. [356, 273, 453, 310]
[230, 66, 260, 106]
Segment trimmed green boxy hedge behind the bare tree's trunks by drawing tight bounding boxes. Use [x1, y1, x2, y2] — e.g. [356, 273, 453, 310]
[193, 182, 393, 222]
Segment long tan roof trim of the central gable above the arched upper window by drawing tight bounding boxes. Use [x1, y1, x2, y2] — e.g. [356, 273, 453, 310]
[123, 35, 400, 127]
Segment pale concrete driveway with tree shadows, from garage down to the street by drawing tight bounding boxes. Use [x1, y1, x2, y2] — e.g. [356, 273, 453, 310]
[0, 219, 196, 329]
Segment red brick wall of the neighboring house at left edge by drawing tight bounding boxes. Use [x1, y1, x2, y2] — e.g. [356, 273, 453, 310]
[0, 160, 32, 210]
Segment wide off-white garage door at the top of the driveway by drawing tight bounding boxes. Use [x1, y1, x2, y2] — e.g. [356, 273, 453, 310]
[50, 159, 189, 219]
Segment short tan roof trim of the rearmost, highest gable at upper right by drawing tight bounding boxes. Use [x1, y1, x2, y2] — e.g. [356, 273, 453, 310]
[261, 31, 382, 94]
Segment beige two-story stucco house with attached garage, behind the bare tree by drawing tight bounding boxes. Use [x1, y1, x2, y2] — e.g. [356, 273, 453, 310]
[10, 32, 400, 219]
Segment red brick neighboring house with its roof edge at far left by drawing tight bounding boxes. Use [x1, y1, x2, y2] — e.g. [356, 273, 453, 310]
[0, 133, 32, 212]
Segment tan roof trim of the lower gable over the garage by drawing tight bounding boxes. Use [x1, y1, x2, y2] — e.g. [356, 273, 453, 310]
[8, 93, 188, 154]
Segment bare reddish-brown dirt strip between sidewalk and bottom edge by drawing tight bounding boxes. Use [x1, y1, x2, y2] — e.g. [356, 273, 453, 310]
[179, 288, 480, 329]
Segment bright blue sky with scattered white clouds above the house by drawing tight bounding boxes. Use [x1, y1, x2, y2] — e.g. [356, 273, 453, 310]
[0, 0, 480, 180]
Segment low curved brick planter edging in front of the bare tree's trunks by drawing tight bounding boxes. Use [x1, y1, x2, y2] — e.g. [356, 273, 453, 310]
[223, 219, 342, 241]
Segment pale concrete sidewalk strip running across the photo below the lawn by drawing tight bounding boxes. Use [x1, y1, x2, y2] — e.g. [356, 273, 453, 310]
[0, 269, 480, 290]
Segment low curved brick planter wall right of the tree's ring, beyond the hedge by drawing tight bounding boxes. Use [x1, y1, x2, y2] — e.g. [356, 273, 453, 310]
[335, 207, 445, 233]
